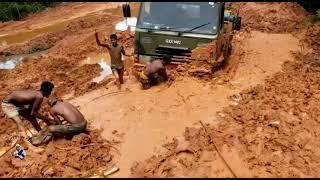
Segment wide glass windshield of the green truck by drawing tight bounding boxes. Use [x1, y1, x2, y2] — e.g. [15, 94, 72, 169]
[137, 2, 220, 34]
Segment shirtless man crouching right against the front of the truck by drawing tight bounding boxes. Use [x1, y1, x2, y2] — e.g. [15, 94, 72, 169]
[138, 55, 171, 89]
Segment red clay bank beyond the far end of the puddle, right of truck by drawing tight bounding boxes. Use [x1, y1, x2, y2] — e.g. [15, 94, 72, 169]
[226, 2, 307, 33]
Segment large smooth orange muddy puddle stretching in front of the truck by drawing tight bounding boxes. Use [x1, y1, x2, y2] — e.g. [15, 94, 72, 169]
[72, 32, 298, 177]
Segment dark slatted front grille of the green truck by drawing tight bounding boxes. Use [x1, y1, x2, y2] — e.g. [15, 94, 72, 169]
[156, 45, 192, 64]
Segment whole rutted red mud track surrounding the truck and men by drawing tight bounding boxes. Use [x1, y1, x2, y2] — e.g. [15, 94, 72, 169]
[0, 3, 320, 177]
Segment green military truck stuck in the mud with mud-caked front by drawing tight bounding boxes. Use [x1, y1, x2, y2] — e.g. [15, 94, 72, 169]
[122, 2, 241, 63]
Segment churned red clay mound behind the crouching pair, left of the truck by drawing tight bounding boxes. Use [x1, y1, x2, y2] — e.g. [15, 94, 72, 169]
[0, 15, 134, 98]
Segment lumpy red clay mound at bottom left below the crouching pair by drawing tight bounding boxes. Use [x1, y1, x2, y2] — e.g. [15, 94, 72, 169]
[0, 127, 117, 178]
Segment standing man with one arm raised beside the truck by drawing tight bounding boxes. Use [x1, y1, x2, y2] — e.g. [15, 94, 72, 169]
[95, 30, 133, 89]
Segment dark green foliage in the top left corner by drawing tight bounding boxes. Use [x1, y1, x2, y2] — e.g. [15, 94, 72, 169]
[0, 2, 57, 21]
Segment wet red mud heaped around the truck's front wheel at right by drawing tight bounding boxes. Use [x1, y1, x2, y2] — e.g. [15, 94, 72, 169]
[168, 32, 249, 82]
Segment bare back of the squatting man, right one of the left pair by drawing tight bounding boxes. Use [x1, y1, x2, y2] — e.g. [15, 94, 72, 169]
[50, 101, 86, 124]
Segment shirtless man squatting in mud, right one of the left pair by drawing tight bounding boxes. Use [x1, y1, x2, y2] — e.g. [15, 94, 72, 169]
[31, 97, 87, 145]
